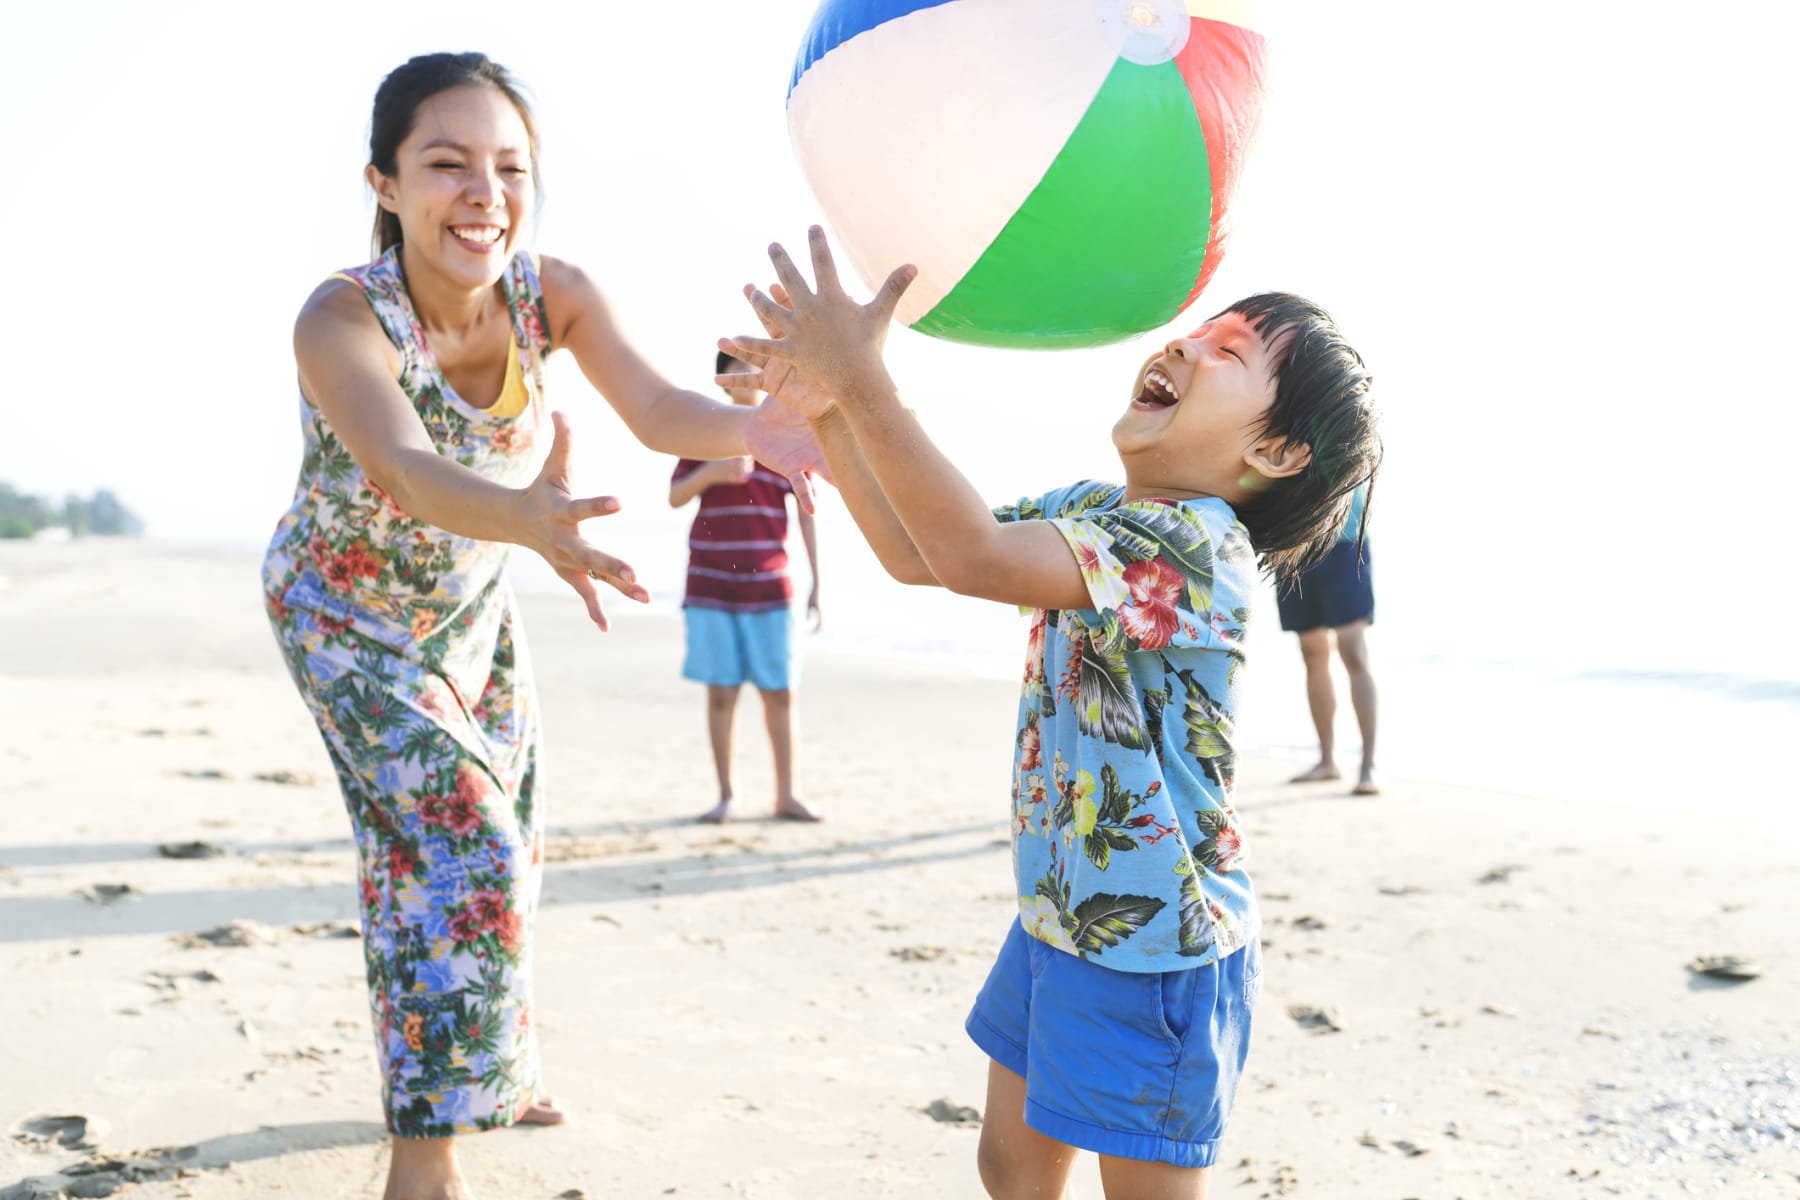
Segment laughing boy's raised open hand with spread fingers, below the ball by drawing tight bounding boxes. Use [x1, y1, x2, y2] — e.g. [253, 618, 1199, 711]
[733, 225, 918, 401]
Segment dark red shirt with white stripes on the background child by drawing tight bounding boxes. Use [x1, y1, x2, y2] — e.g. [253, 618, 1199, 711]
[670, 459, 794, 612]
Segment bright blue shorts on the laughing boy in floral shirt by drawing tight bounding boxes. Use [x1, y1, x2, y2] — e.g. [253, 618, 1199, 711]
[963, 921, 1262, 1168]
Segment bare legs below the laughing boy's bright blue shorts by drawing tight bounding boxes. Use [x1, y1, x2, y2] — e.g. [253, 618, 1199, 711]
[976, 1061, 1211, 1200]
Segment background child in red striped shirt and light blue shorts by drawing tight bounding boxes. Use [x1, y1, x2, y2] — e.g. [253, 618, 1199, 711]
[670, 351, 819, 824]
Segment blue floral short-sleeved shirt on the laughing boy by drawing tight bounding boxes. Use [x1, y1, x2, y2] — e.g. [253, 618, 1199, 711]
[994, 482, 1260, 972]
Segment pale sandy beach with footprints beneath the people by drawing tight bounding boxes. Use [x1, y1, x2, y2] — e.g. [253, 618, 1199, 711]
[0, 542, 1800, 1200]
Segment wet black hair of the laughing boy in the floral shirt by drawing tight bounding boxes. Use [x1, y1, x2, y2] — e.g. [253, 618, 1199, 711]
[1220, 291, 1382, 585]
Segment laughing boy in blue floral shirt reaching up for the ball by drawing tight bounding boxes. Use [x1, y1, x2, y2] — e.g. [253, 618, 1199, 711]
[724, 228, 1381, 1200]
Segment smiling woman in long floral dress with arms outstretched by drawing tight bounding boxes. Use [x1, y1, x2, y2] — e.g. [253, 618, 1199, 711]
[263, 54, 806, 1200]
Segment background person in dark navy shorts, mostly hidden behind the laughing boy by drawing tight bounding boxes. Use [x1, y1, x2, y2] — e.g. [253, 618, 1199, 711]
[1276, 488, 1381, 795]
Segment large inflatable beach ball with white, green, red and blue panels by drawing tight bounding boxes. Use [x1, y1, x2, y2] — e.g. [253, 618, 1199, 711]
[787, 0, 1265, 349]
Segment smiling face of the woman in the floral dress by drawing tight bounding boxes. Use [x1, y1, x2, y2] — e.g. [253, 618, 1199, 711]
[369, 85, 536, 288]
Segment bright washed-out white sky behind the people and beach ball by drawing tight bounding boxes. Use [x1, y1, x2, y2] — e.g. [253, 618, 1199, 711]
[0, 0, 1800, 690]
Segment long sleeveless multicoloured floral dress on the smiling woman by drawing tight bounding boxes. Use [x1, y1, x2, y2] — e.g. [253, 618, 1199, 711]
[263, 250, 547, 1137]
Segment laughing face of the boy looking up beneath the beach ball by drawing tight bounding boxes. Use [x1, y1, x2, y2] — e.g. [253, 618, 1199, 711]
[1112, 313, 1296, 502]
